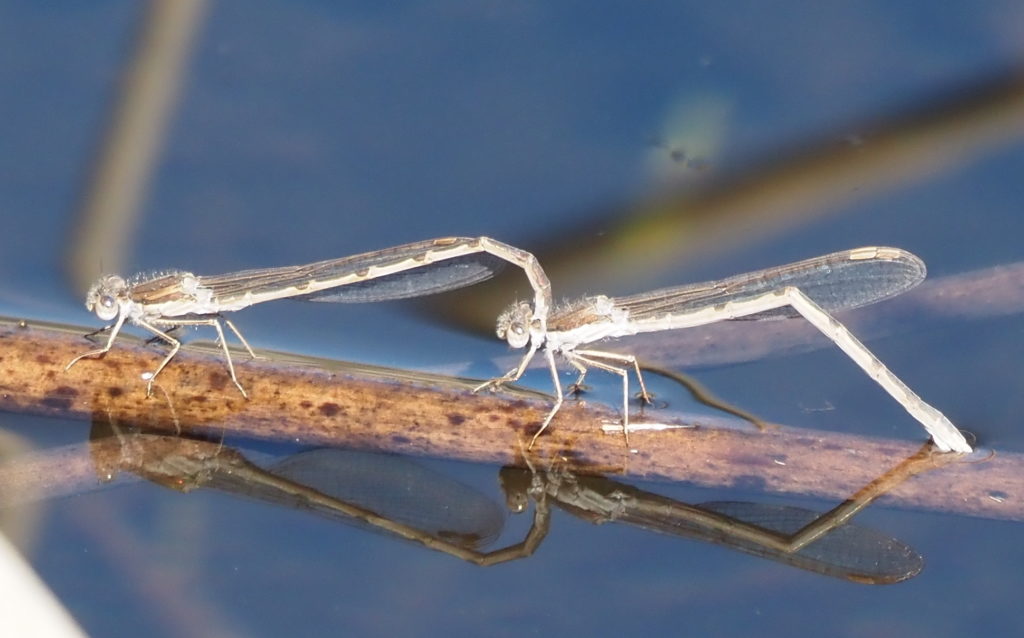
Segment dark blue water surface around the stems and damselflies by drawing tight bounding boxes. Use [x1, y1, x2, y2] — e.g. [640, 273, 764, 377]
[0, 1, 1024, 636]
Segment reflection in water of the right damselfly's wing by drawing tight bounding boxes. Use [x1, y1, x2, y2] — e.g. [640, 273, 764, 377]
[617, 501, 924, 585]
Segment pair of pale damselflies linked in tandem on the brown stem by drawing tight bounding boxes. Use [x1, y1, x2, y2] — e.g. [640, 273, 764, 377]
[67, 238, 971, 453]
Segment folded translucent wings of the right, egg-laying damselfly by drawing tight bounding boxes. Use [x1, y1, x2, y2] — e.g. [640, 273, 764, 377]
[606, 248, 926, 323]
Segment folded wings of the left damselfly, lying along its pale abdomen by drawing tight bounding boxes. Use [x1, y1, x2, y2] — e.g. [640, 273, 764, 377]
[198, 238, 505, 307]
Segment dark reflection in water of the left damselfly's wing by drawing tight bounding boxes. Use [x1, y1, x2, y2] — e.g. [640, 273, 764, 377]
[232, 449, 505, 548]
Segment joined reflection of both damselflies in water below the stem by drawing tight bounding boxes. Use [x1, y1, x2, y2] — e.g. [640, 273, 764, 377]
[97, 433, 934, 584]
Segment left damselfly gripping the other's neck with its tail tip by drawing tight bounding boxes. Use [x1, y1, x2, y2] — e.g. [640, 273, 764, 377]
[67, 237, 551, 395]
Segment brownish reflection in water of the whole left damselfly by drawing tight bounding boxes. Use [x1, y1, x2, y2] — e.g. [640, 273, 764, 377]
[93, 432, 549, 565]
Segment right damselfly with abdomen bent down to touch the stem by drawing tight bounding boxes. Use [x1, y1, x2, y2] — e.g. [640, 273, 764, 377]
[480, 247, 971, 452]
